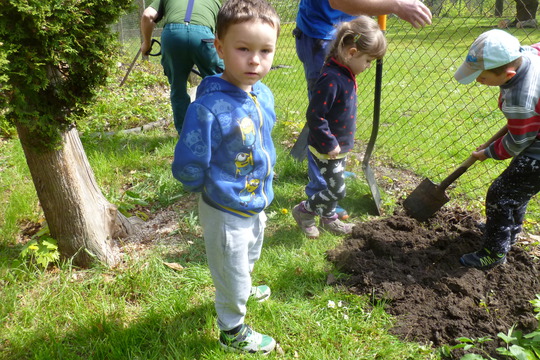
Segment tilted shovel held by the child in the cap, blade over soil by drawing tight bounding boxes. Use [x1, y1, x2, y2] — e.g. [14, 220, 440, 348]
[403, 126, 507, 221]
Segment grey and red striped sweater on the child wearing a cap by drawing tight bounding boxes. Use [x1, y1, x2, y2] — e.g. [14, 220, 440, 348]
[485, 52, 540, 160]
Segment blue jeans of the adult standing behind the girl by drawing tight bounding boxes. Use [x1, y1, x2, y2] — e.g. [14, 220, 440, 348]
[293, 28, 330, 197]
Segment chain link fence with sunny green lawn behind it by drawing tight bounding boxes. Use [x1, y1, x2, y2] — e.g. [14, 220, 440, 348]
[112, 0, 540, 223]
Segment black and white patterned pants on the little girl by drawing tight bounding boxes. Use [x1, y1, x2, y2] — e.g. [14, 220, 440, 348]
[306, 156, 347, 217]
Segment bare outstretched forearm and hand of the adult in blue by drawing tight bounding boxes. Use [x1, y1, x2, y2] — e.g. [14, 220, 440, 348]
[329, 0, 431, 28]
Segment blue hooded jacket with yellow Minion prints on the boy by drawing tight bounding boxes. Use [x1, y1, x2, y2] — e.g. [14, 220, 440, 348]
[172, 75, 276, 217]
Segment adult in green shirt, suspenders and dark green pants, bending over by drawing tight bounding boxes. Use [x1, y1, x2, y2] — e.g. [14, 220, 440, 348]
[141, 0, 223, 133]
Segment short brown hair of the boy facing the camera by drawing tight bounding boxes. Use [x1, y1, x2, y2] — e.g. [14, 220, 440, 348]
[216, 0, 280, 39]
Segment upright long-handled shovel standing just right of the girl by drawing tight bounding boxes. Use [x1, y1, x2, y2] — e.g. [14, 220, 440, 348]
[362, 15, 386, 215]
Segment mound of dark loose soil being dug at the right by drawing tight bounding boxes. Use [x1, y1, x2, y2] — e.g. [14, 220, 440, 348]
[328, 209, 540, 356]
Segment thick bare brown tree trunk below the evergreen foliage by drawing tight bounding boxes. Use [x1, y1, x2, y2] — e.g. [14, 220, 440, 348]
[17, 125, 134, 267]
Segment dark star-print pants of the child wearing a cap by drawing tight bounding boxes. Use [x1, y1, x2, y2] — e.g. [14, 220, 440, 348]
[484, 156, 540, 254]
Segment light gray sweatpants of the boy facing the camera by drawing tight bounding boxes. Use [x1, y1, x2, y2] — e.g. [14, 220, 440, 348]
[199, 198, 266, 330]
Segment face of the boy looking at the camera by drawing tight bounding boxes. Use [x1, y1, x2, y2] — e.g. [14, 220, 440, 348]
[215, 20, 277, 91]
